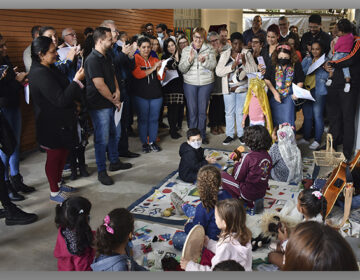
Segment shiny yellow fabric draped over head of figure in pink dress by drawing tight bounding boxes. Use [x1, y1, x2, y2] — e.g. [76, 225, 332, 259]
[243, 78, 273, 135]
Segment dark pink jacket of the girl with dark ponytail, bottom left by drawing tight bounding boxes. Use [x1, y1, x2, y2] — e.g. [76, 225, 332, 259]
[54, 228, 95, 271]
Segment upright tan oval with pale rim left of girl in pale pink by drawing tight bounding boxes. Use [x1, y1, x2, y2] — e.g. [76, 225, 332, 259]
[182, 225, 205, 262]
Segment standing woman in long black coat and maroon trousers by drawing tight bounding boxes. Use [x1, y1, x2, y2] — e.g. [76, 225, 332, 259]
[29, 36, 85, 203]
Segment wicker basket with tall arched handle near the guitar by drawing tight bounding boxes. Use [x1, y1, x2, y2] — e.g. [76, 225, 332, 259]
[313, 133, 345, 166]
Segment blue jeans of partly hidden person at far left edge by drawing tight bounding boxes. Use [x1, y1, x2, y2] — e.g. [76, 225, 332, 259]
[0, 108, 21, 180]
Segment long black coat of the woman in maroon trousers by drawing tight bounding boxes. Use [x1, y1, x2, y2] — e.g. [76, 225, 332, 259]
[29, 61, 82, 149]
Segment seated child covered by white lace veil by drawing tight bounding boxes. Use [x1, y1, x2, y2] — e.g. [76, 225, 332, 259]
[269, 123, 302, 184]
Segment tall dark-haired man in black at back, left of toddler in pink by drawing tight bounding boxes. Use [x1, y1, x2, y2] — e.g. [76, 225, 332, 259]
[300, 14, 331, 57]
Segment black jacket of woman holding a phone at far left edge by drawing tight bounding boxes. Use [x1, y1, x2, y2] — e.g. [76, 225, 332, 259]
[0, 56, 23, 108]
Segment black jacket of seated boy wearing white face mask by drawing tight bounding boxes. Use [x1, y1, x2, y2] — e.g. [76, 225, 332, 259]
[179, 142, 208, 183]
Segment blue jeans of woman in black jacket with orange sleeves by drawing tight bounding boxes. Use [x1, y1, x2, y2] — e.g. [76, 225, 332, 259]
[134, 96, 162, 144]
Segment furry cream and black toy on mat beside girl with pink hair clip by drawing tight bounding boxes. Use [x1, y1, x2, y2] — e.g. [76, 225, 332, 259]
[260, 212, 298, 237]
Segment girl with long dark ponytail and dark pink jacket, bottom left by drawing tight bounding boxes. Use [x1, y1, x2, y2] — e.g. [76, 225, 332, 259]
[54, 196, 95, 271]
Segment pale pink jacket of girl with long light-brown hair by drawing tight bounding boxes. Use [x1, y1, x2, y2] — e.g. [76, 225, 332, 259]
[185, 234, 252, 271]
